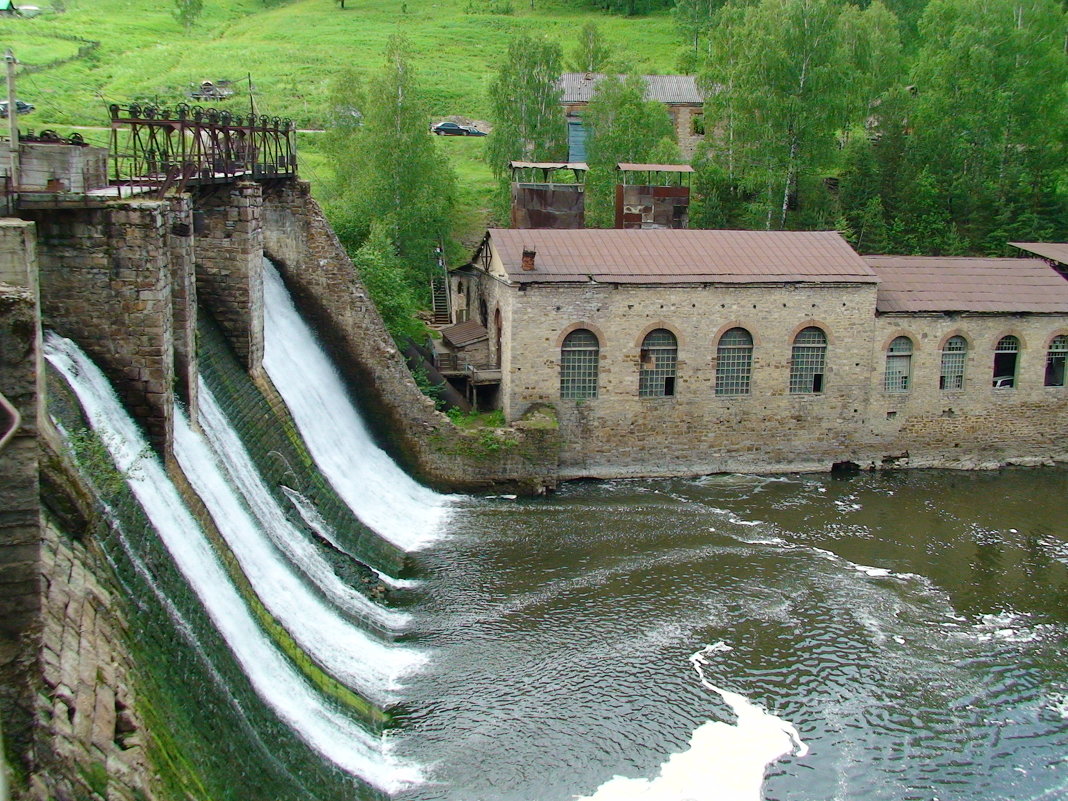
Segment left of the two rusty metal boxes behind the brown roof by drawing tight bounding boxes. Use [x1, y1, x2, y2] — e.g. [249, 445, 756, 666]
[508, 161, 590, 229]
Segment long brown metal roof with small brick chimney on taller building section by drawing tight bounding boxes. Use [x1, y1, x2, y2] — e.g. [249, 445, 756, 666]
[488, 229, 878, 283]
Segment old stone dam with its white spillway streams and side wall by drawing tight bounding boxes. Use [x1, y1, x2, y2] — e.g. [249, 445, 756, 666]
[0, 158, 555, 799]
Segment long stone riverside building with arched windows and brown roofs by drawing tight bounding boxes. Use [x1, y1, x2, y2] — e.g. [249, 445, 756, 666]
[452, 230, 1068, 477]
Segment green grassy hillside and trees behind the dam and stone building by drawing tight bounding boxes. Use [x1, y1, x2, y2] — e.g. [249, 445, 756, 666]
[0, 0, 1068, 337]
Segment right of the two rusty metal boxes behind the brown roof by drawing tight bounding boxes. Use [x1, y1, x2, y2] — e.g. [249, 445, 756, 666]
[615, 163, 693, 229]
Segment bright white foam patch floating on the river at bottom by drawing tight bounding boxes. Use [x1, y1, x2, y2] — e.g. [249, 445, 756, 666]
[576, 642, 808, 801]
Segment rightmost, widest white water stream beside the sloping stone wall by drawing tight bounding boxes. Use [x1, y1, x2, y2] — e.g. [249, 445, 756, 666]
[264, 260, 449, 551]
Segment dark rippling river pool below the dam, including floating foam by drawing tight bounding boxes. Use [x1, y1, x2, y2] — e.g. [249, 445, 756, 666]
[399, 470, 1068, 801]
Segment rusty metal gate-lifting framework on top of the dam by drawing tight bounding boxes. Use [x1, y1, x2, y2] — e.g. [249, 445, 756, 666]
[110, 104, 297, 195]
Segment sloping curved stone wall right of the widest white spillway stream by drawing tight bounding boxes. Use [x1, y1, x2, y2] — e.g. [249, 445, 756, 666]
[263, 182, 557, 491]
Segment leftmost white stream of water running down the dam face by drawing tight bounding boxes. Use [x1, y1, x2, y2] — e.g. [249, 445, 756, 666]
[45, 333, 422, 792]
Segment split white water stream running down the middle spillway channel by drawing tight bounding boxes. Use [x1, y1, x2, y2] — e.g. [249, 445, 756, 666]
[174, 384, 425, 703]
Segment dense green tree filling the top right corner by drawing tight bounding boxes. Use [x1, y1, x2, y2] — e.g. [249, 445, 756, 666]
[909, 0, 1068, 250]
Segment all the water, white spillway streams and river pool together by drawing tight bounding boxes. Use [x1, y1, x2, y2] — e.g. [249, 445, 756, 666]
[41, 261, 1068, 801]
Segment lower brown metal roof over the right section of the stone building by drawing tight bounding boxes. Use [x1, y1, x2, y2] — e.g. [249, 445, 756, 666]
[864, 256, 1068, 314]
